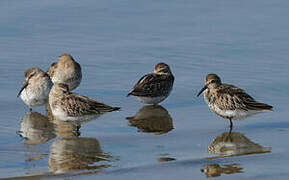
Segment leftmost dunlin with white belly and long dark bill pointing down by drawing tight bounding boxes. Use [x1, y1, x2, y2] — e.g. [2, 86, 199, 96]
[17, 67, 52, 110]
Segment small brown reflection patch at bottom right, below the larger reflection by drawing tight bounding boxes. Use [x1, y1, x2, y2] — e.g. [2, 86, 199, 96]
[201, 164, 243, 178]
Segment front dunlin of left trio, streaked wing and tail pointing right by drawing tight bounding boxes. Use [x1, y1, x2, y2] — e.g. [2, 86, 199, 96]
[49, 83, 120, 121]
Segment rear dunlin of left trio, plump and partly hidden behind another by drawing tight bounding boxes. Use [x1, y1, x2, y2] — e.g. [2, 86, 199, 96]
[47, 53, 82, 91]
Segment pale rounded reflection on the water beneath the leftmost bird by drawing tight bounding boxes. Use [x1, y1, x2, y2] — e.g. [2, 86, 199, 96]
[18, 111, 56, 143]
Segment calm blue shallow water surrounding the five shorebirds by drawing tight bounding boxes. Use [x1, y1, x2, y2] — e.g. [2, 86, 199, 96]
[0, 0, 289, 179]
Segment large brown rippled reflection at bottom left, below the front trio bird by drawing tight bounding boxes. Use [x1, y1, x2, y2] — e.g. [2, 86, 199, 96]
[48, 137, 112, 173]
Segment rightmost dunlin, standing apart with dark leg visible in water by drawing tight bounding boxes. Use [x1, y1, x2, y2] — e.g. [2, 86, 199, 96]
[197, 74, 273, 130]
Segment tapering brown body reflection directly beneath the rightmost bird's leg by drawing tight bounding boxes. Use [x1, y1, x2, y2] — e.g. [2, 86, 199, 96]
[208, 132, 271, 157]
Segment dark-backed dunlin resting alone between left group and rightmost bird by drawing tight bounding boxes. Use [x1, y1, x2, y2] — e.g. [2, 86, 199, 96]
[127, 63, 174, 105]
